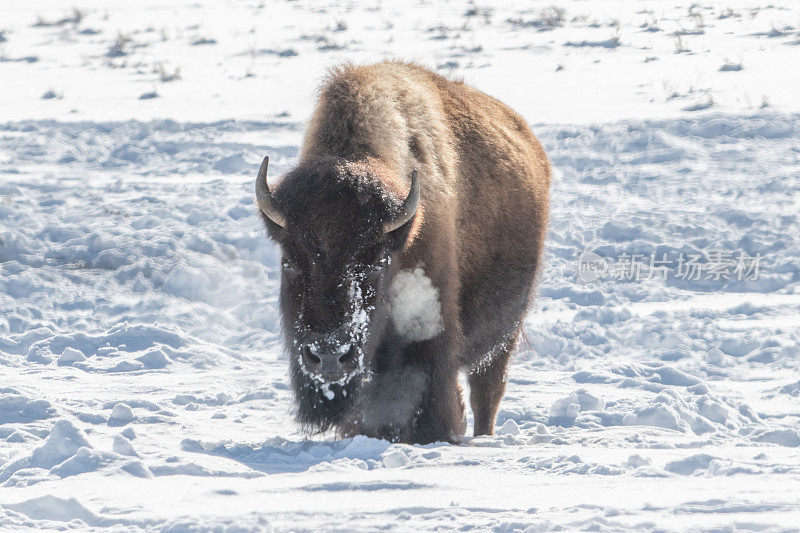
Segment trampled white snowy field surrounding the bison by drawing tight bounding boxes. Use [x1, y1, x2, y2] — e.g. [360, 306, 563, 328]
[0, 0, 800, 532]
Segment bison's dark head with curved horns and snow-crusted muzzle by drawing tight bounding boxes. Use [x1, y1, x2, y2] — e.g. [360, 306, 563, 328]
[256, 159, 419, 390]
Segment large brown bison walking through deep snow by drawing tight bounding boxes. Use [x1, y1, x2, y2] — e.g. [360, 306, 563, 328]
[256, 61, 550, 443]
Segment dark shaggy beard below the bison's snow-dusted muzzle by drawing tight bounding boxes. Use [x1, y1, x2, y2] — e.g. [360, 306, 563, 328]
[291, 358, 362, 433]
